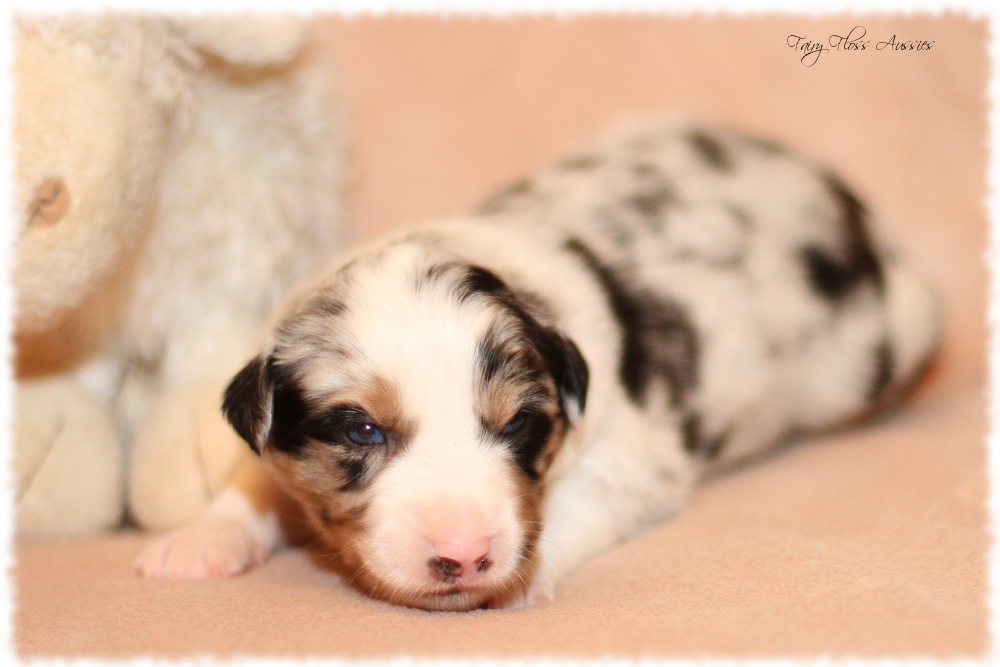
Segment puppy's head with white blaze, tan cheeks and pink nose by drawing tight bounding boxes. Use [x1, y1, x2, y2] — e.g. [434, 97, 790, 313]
[223, 243, 587, 610]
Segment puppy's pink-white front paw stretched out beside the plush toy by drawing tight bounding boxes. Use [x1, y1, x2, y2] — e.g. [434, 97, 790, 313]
[135, 518, 271, 579]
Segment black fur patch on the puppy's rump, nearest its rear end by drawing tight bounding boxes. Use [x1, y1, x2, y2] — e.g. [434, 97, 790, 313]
[800, 174, 885, 304]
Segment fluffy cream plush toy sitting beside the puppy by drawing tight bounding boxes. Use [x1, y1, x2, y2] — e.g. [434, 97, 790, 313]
[13, 14, 342, 537]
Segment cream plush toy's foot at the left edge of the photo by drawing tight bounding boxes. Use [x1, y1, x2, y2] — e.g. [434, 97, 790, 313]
[14, 378, 124, 538]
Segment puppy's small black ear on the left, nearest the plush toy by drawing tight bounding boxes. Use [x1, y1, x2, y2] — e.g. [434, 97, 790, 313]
[222, 354, 274, 455]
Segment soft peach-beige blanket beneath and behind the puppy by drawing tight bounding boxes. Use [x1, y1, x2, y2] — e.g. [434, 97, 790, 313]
[13, 14, 989, 657]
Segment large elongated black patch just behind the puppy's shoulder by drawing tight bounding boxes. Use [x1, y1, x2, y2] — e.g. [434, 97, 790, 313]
[564, 238, 698, 407]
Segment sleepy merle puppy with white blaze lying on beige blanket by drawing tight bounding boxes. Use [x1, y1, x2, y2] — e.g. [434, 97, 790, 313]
[139, 121, 938, 610]
